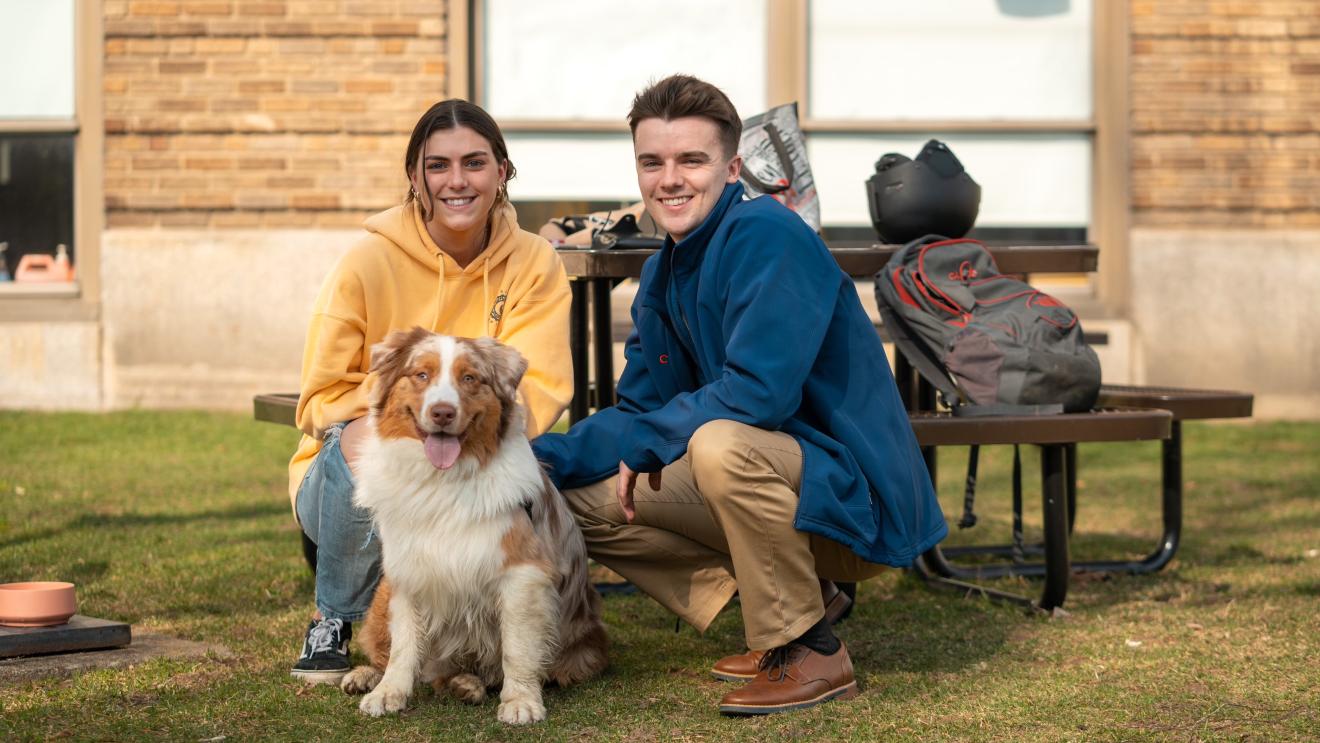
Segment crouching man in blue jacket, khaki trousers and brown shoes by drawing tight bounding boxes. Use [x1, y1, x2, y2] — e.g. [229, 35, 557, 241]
[533, 75, 948, 714]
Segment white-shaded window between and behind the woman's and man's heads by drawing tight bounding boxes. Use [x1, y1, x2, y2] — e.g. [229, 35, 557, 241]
[475, 0, 768, 201]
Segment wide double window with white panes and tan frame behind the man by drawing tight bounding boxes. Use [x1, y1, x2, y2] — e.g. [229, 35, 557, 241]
[462, 0, 1126, 261]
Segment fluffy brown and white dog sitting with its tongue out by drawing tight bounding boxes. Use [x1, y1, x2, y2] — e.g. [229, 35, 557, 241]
[341, 327, 607, 725]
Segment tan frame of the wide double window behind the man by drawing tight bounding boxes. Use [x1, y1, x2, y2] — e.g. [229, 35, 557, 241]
[449, 0, 1131, 314]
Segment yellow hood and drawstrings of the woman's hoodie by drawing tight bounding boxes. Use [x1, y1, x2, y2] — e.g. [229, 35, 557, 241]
[363, 202, 519, 335]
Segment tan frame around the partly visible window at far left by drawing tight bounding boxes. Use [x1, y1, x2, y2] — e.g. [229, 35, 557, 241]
[0, 0, 106, 322]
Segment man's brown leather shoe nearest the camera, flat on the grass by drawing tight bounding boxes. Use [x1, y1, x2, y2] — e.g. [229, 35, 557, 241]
[719, 643, 859, 714]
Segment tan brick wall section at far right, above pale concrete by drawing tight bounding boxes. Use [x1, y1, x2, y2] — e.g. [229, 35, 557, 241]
[1131, 0, 1320, 228]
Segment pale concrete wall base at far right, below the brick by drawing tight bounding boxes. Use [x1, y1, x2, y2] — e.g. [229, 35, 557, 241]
[1130, 227, 1320, 411]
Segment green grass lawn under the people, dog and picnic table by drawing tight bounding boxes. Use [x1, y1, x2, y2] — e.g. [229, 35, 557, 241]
[0, 412, 1320, 740]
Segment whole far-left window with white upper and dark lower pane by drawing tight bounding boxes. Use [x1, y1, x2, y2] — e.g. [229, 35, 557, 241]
[0, 0, 104, 311]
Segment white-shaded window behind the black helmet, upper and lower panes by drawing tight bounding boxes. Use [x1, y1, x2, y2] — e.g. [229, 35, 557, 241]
[804, 0, 1093, 228]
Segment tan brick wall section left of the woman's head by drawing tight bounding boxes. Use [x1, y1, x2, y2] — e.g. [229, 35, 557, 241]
[104, 0, 447, 227]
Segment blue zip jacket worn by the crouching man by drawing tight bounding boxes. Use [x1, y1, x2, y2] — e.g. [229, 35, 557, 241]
[533, 183, 948, 567]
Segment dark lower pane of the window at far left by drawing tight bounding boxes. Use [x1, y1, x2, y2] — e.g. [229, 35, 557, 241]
[0, 133, 77, 276]
